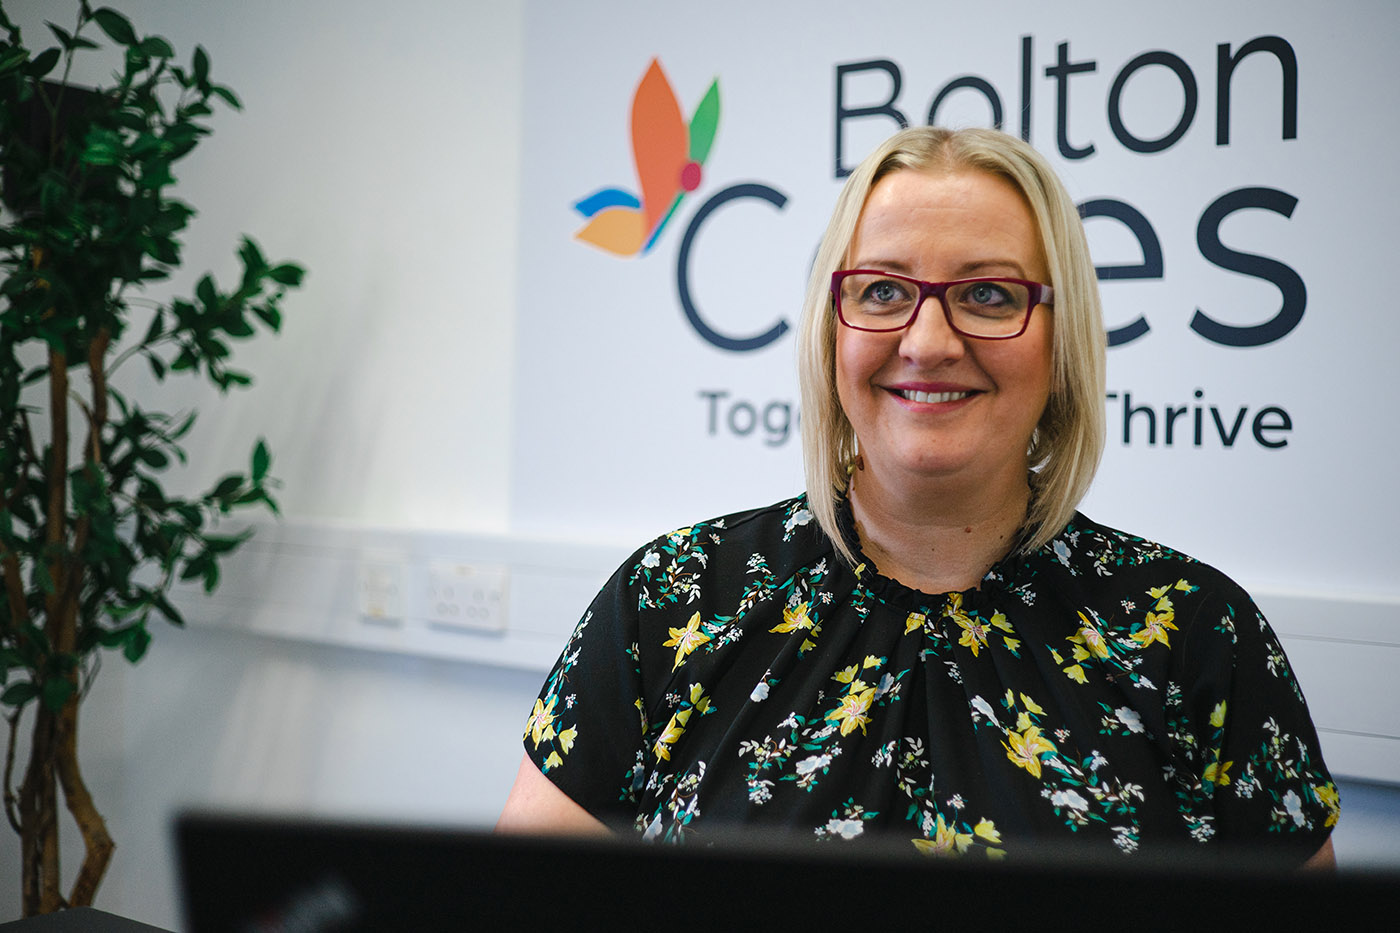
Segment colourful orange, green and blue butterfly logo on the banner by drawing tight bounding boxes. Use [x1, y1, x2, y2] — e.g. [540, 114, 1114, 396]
[574, 59, 720, 256]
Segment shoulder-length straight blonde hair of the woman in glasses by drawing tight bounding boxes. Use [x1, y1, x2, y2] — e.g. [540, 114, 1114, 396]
[798, 126, 1106, 563]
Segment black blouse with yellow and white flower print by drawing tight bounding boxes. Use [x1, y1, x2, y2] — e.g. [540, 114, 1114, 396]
[525, 496, 1338, 860]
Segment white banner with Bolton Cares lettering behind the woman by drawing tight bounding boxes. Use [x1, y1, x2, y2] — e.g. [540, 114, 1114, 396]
[511, 0, 1400, 597]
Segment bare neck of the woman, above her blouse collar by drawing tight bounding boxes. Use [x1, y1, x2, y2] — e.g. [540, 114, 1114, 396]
[850, 468, 1030, 593]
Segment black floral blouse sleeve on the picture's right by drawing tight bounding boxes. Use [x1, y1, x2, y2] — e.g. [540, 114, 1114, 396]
[1177, 580, 1340, 862]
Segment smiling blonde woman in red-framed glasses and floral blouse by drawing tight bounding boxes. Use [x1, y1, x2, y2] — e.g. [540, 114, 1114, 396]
[500, 127, 1338, 864]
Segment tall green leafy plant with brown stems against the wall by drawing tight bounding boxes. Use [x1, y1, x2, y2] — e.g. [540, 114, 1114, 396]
[0, 0, 302, 916]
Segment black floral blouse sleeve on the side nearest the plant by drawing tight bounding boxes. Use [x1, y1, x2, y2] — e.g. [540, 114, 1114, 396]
[524, 552, 643, 825]
